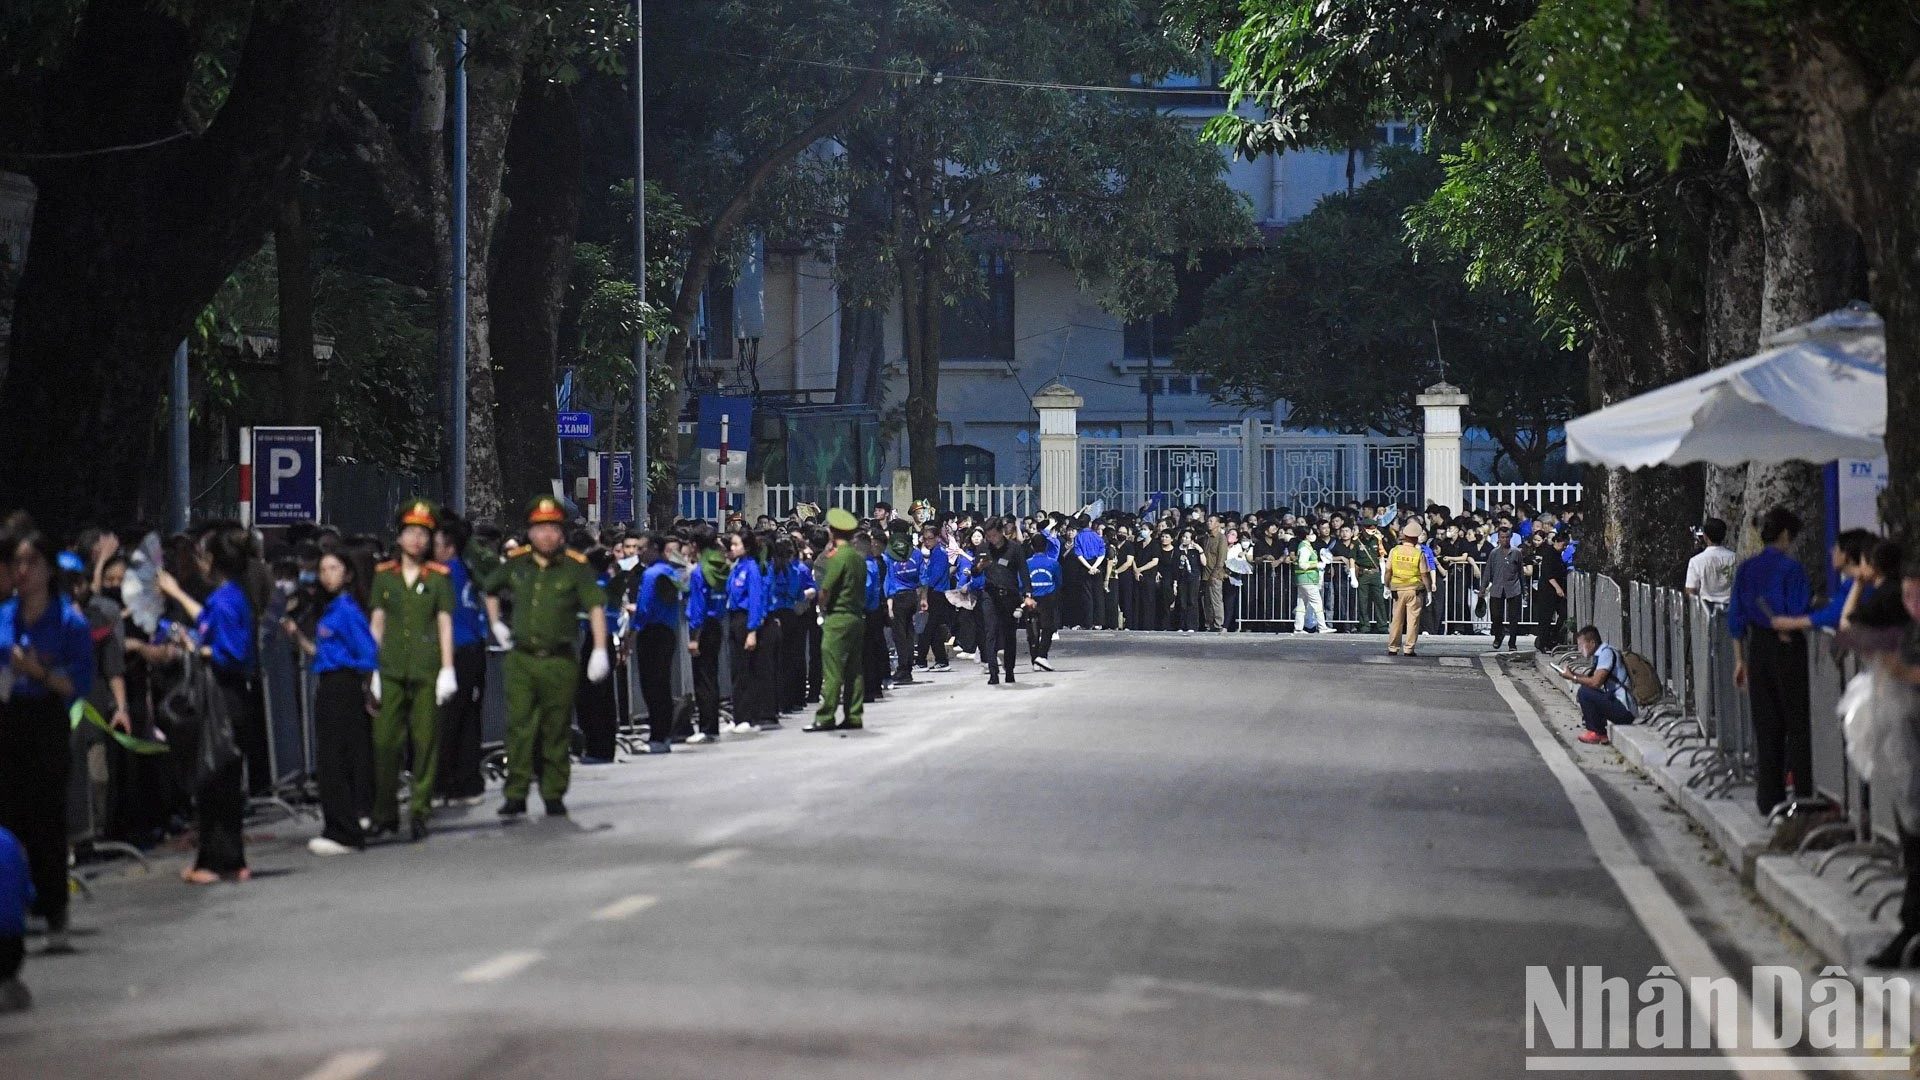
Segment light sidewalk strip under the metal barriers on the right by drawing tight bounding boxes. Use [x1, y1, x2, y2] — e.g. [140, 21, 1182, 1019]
[1509, 653, 1905, 974]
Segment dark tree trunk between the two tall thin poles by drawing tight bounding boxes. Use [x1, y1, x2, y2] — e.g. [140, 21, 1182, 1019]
[492, 75, 586, 498]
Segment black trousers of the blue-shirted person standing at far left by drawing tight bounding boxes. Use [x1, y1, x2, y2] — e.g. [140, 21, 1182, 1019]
[0, 698, 73, 930]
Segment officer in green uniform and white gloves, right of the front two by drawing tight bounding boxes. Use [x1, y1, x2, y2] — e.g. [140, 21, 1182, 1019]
[486, 496, 612, 819]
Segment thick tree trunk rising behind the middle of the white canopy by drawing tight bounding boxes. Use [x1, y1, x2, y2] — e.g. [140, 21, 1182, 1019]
[1730, 125, 1857, 568]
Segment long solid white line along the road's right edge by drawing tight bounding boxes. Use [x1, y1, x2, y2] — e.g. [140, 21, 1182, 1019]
[1480, 659, 1803, 1076]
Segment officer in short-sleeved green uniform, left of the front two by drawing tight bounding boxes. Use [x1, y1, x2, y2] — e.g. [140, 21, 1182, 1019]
[371, 500, 457, 840]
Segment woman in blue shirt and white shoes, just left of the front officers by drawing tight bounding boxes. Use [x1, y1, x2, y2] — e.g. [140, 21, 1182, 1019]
[286, 552, 380, 855]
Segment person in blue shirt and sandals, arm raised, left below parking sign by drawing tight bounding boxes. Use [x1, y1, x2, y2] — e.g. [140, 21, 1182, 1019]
[159, 525, 265, 884]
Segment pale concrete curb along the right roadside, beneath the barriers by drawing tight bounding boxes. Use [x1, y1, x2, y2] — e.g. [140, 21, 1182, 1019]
[1534, 641, 1899, 969]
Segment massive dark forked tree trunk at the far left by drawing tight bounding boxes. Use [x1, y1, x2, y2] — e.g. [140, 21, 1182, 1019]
[0, 0, 342, 534]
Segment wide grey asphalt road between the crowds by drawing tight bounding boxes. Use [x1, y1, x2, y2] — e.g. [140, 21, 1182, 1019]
[0, 634, 1657, 1080]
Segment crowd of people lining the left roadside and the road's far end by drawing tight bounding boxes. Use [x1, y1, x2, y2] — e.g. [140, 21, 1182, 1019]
[0, 488, 1576, 1007]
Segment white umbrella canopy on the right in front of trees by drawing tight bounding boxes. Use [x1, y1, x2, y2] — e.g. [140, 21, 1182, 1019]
[1567, 304, 1887, 469]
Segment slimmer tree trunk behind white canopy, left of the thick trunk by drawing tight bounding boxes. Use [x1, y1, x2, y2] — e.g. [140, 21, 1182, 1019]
[1701, 132, 1766, 536]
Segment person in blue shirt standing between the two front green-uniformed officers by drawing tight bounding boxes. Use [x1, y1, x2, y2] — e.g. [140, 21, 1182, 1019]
[434, 511, 492, 805]
